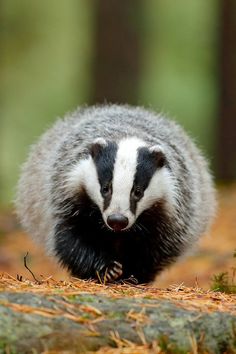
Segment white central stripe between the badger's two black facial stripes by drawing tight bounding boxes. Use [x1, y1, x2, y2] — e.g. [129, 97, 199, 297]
[106, 137, 146, 215]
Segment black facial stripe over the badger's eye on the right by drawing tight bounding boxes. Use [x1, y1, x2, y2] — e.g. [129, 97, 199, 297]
[130, 147, 158, 214]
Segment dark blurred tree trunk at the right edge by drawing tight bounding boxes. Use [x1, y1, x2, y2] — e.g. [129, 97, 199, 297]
[218, 0, 236, 180]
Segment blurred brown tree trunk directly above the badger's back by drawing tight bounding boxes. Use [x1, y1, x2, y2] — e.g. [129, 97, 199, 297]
[92, 0, 142, 104]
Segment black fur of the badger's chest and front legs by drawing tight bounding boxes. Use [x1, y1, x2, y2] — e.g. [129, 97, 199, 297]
[55, 195, 181, 283]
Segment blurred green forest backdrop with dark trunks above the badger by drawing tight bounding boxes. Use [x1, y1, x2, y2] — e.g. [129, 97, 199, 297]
[0, 0, 236, 207]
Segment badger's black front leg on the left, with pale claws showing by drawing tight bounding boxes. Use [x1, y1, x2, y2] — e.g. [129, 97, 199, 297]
[55, 226, 122, 283]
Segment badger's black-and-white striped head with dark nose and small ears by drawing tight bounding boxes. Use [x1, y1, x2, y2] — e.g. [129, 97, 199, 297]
[66, 137, 174, 231]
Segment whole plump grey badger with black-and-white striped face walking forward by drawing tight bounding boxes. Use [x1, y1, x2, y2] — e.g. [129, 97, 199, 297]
[16, 104, 216, 283]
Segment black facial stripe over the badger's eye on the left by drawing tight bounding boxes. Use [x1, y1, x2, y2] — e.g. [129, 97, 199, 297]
[93, 142, 118, 210]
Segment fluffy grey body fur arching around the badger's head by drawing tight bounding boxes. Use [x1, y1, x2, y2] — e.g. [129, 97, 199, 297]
[16, 105, 216, 280]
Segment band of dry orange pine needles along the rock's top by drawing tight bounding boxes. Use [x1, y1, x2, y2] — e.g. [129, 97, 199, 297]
[0, 273, 236, 316]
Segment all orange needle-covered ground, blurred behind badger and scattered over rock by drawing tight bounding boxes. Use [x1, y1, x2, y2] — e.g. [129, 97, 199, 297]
[0, 184, 236, 354]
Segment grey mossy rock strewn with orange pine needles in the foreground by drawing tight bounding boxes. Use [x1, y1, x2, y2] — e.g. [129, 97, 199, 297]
[0, 274, 236, 354]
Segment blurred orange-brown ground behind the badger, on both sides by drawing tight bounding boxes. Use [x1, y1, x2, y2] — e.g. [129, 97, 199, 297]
[0, 184, 236, 289]
